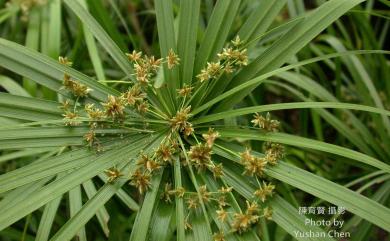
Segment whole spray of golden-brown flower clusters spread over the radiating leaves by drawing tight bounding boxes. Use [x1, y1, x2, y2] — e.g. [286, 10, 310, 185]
[59, 37, 284, 238]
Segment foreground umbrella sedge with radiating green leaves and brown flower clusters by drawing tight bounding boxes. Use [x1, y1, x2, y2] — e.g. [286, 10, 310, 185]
[0, 0, 390, 241]
